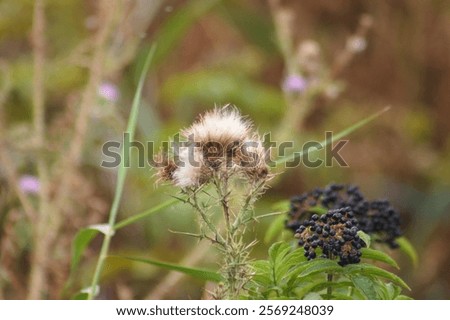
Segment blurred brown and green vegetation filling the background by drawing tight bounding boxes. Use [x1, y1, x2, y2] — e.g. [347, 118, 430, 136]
[0, 0, 450, 299]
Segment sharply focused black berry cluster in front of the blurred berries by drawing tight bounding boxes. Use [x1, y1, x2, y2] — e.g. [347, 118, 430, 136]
[295, 207, 365, 266]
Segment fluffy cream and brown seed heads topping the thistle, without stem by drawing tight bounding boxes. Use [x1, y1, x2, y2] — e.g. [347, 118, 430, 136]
[158, 105, 269, 188]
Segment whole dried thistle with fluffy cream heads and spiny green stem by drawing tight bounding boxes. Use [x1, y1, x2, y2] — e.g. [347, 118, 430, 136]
[158, 105, 270, 299]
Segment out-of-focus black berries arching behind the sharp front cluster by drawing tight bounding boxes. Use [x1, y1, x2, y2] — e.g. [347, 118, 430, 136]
[286, 184, 401, 248]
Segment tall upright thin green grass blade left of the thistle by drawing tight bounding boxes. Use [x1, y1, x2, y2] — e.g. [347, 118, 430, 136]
[88, 46, 155, 300]
